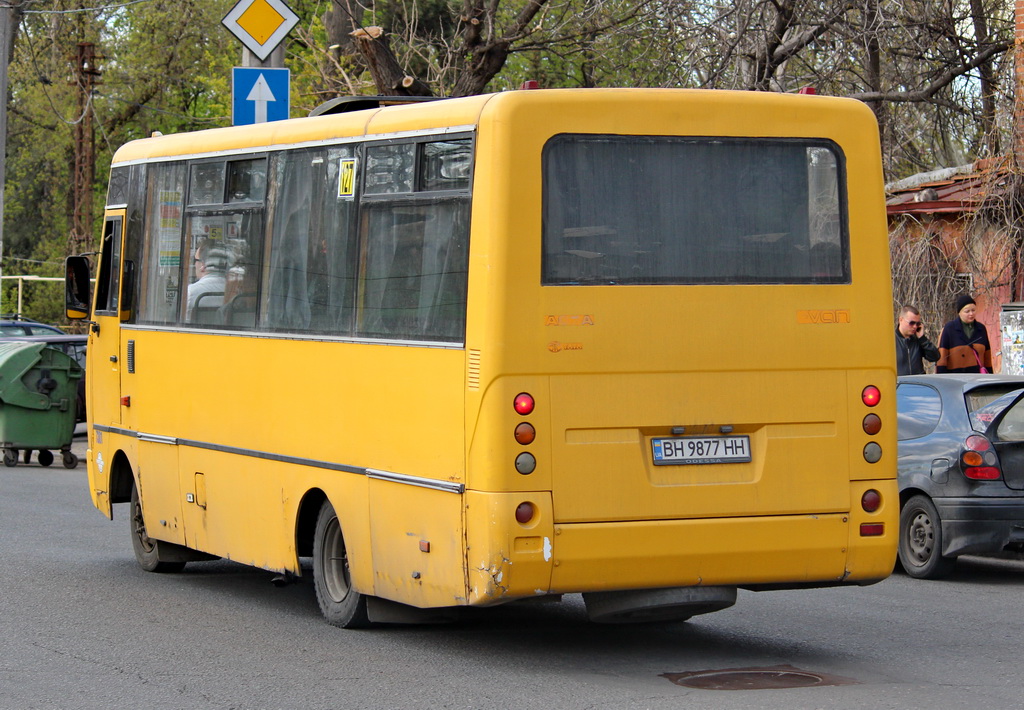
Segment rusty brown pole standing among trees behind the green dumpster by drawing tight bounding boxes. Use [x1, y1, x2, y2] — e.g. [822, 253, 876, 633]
[68, 42, 99, 254]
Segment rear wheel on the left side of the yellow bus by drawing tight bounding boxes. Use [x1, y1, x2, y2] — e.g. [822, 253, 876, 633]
[313, 501, 370, 629]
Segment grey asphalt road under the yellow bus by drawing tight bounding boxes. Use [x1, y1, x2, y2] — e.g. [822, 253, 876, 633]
[0, 442, 1024, 710]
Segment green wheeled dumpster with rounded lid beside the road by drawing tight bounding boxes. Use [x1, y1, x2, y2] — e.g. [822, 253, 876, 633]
[0, 341, 82, 468]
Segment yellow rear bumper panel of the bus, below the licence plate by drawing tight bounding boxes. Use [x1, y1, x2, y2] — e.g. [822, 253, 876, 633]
[551, 513, 896, 593]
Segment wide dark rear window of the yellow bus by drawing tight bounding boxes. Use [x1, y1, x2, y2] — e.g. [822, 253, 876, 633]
[543, 135, 850, 285]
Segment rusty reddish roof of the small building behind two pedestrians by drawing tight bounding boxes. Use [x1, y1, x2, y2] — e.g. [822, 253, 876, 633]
[886, 158, 1010, 214]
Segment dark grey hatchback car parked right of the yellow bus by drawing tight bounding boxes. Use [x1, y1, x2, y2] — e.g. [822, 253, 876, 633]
[896, 374, 1024, 579]
